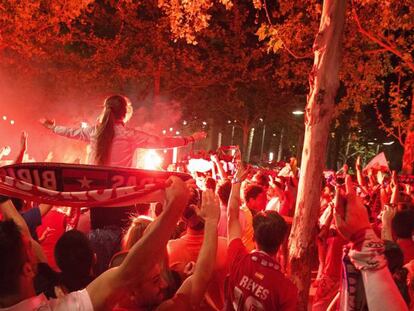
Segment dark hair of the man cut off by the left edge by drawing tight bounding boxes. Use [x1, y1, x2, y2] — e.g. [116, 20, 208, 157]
[0, 220, 28, 297]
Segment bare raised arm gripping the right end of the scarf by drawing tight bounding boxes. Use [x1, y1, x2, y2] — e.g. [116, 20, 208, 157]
[86, 177, 189, 310]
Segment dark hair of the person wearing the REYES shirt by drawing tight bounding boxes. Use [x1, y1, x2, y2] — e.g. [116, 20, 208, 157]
[253, 211, 288, 254]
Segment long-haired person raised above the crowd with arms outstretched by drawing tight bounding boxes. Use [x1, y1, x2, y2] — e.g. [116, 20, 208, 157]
[40, 95, 206, 274]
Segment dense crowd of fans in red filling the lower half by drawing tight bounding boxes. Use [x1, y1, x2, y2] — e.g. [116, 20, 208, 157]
[0, 95, 414, 310]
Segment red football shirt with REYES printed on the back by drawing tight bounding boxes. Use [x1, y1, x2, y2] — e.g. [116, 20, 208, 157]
[226, 239, 297, 311]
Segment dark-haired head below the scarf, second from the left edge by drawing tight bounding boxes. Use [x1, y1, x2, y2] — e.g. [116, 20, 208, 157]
[55, 230, 94, 291]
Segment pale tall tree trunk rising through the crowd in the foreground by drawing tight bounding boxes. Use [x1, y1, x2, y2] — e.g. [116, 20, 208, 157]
[289, 0, 345, 310]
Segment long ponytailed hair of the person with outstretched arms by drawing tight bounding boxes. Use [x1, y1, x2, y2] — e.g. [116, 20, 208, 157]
[95, 95, 128, 165]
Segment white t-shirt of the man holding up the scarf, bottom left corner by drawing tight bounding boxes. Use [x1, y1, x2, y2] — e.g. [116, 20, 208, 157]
[0, 289, 93, 311]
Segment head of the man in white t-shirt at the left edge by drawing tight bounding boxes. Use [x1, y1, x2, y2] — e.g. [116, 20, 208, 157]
[0, 220, 35, 297]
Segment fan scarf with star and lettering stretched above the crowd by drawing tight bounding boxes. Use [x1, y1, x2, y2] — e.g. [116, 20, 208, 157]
[0, 163, 191, 207]
